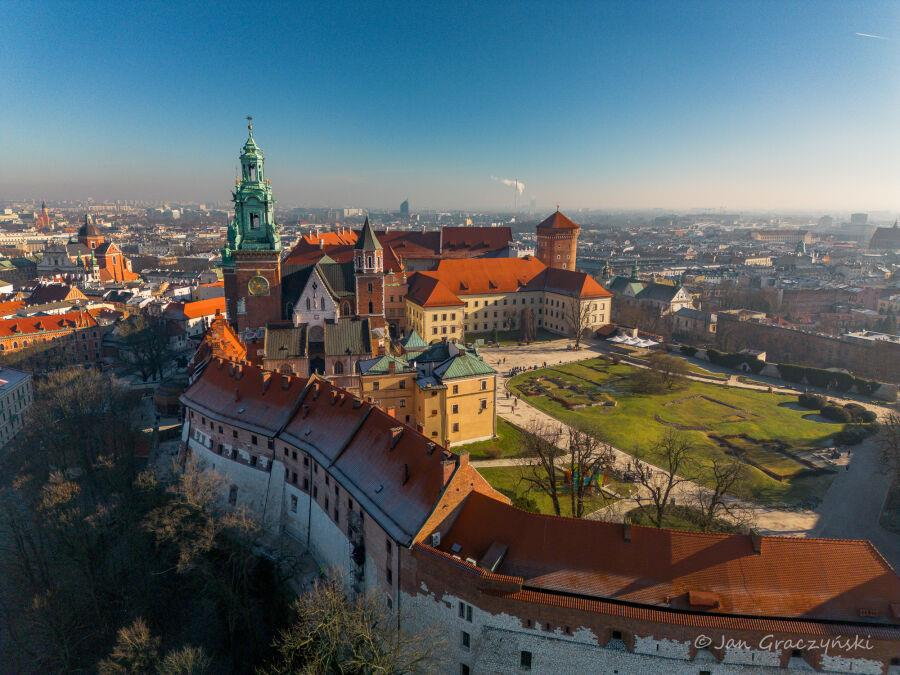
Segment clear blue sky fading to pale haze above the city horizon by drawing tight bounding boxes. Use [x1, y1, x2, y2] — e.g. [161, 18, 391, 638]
[0, 0, 900, 210]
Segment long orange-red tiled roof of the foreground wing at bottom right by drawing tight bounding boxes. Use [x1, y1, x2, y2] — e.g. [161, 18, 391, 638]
[440, 493, 900, 621]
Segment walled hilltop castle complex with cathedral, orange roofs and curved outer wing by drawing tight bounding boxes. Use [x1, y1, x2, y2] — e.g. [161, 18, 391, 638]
[181, 124, 900, 675]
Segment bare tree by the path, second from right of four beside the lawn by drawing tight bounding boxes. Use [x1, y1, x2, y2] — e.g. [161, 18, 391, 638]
[628, 429, 694, 527]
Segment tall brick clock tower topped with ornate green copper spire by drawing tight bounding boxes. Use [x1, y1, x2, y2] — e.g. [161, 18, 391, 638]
[222, 116, 281, 340]
